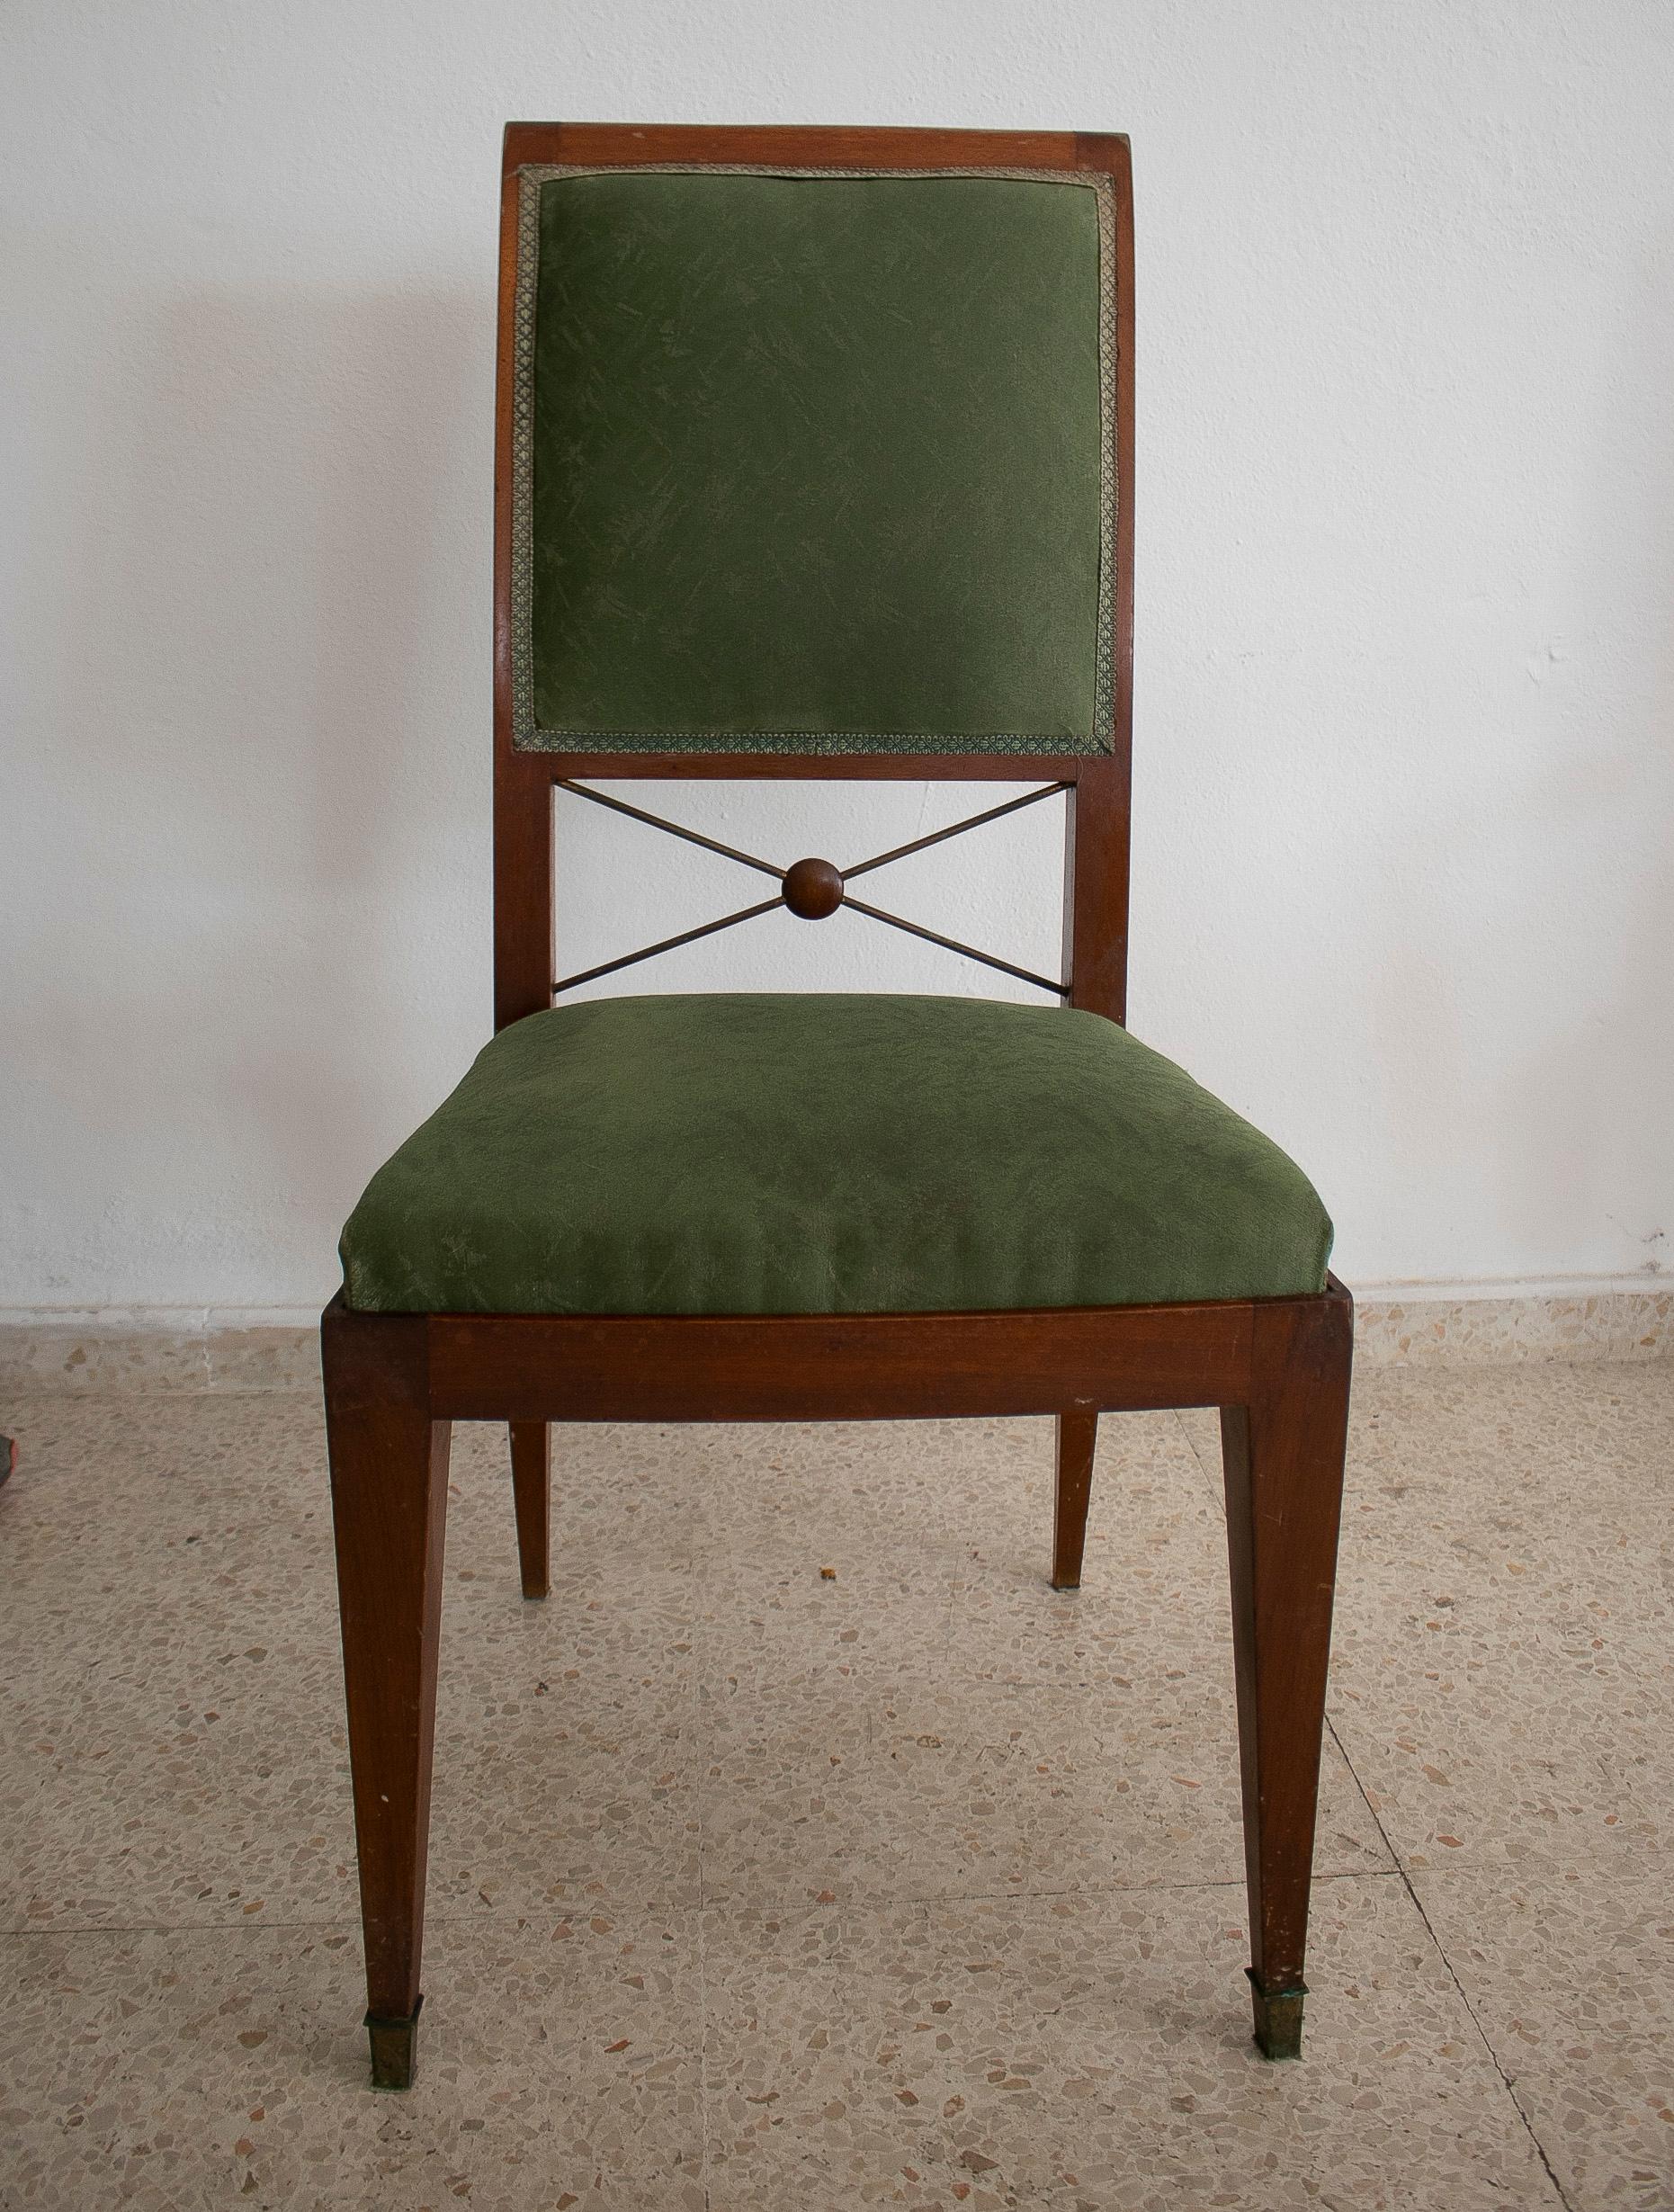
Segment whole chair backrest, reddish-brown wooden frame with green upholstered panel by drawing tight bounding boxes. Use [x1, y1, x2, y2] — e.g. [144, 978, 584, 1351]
[496, 124, 1134, 1026]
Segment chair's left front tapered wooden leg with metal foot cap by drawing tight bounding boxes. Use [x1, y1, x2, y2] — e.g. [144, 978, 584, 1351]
[320, 1305, 449, 2088]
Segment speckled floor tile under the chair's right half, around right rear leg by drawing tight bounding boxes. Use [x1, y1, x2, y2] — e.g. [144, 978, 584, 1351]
[701, 1416, 1391, 1903]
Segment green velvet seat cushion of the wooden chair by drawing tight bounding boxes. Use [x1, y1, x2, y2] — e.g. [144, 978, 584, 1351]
[343, 993, 1331, 1314]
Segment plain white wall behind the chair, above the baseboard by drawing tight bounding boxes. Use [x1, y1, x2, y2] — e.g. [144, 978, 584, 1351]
[0, 0, 1674, 1307]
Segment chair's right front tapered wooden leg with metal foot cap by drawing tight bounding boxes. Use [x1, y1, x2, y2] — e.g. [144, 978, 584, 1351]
[1221, 1285, 1354, 2059]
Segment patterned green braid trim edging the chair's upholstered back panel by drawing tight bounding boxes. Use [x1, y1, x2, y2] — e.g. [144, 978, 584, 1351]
[511, 162, 1119, 757]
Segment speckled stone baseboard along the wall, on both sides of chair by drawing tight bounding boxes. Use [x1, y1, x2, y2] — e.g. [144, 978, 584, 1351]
[0, 1276, 1674, 1392]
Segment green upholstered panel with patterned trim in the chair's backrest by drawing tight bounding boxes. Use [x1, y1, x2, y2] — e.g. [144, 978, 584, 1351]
[511, 168, 1116, 755]
